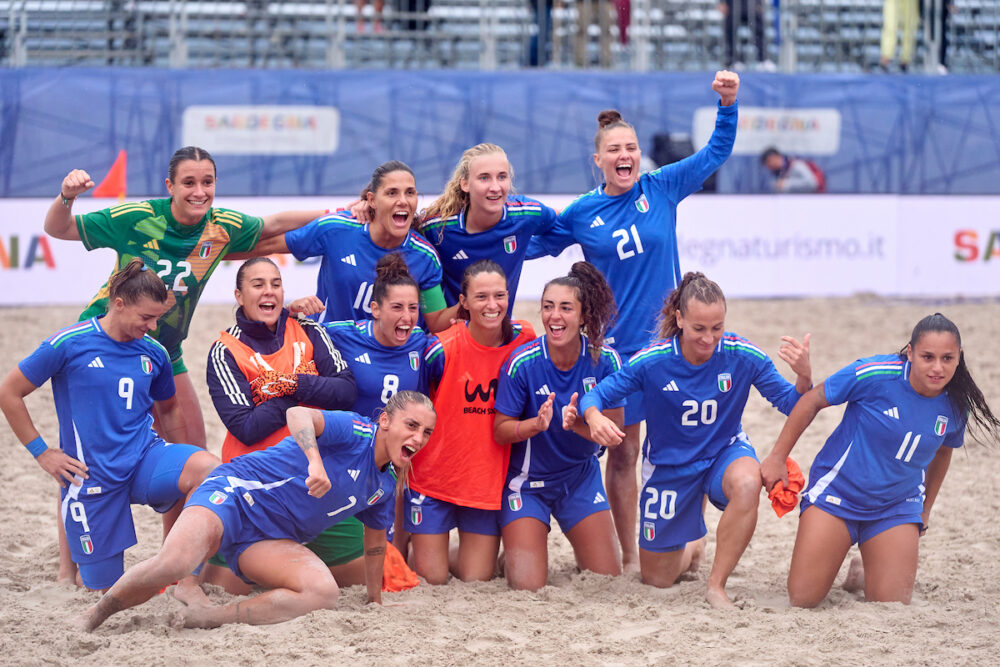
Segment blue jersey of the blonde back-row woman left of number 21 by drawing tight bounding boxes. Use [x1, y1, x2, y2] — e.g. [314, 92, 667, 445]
[420, 195, 556, 315]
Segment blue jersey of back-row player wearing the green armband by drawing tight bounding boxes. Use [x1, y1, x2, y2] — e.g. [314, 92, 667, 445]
[285, 212, 441, 322]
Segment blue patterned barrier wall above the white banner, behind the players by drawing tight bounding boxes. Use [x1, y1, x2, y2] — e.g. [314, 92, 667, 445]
[0, 68, 1000, 197]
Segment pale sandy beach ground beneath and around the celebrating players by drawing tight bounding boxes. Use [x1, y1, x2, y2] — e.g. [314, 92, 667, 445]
[0, 296, 1000, 667]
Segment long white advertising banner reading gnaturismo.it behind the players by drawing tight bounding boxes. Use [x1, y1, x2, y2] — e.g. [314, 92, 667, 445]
[0, 195, 1000, 305]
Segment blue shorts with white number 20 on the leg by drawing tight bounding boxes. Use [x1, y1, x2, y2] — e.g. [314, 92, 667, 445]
[639, 433, 758, 553]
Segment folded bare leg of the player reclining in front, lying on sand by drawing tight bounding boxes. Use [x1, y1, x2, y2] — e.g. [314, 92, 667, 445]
[181, 540, 340, 628]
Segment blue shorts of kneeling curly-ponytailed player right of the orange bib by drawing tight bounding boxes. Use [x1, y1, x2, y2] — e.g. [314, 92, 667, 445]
[500, 456, 610, 533]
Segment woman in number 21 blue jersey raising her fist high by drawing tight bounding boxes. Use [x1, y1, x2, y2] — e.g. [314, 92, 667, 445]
[528, 71, 740, 570]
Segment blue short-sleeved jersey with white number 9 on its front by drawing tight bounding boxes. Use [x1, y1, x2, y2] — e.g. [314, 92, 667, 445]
[18, 318, 174, 487]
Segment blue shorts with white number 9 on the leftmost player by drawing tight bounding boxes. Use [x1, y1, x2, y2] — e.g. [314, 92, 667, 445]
[62, 440, 205, 590]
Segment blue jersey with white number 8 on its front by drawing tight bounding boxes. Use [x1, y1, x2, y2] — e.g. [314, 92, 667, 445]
[326, 320, 440, 419]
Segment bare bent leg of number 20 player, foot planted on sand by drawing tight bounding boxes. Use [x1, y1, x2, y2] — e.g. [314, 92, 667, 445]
[705, 457, 760, 609]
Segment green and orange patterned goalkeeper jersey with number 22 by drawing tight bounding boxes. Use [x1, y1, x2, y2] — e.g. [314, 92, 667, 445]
[75, 199, 264, 362]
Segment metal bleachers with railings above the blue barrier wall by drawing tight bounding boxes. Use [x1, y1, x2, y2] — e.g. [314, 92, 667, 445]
[0, 0, 1000, 74]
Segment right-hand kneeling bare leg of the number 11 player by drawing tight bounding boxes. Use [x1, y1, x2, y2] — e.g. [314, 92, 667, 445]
[860, 523, 920, 604]
